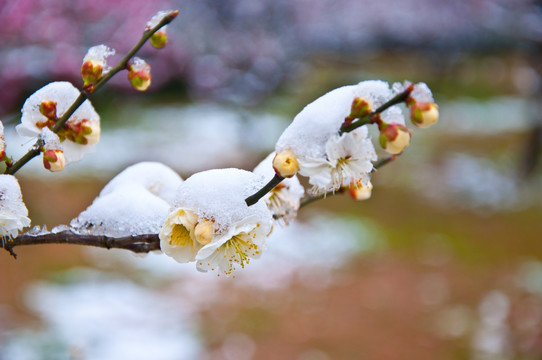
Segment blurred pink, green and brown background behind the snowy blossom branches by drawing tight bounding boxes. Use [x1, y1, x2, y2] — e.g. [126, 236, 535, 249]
[0, 0, 542, 360]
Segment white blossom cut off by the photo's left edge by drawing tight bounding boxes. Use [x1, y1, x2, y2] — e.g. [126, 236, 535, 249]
[0, 175, 30, 242]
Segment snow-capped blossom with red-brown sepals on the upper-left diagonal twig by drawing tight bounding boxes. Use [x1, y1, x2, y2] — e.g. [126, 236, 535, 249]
[16, 81, 100, 163]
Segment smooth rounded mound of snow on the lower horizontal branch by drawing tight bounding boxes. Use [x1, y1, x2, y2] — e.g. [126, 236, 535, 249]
[70, 162, 182, 237]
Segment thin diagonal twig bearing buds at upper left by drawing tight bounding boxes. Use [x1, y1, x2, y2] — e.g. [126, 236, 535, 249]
[4, 10, 179, 175]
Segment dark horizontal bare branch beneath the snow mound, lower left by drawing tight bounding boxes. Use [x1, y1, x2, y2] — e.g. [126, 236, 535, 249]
[3, 230, 160, 258]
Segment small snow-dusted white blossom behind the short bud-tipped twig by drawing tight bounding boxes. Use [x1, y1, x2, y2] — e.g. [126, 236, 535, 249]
[253, 152, 305, 225]
